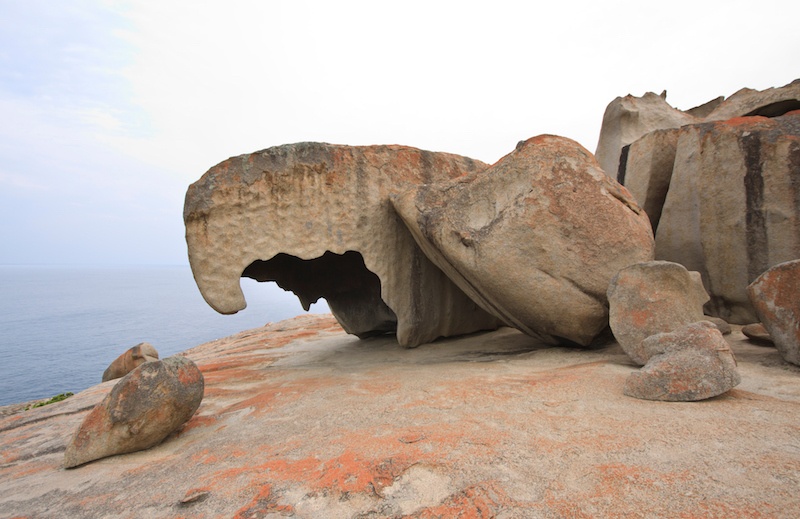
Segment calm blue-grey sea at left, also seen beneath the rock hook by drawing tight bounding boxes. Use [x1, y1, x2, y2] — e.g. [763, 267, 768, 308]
[0, 265, 329, 406]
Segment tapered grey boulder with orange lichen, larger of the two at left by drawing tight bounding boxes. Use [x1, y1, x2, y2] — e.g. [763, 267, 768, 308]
[64, 356, 204, 468]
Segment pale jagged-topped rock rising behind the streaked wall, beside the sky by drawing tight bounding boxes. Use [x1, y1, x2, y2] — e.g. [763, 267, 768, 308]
[595, 92, 700, 180]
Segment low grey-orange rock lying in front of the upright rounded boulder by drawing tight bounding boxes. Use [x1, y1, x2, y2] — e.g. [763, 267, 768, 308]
[624, 321, 741, 402]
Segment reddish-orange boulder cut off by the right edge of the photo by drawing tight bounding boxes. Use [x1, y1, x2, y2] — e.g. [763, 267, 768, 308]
[747, 260, 800, 365]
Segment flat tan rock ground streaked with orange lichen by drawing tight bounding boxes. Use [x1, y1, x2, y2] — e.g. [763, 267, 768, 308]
[0, 316, 800, 518]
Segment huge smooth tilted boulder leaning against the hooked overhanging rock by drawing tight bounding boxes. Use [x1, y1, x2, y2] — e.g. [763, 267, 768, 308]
[392, 135, 653, 346]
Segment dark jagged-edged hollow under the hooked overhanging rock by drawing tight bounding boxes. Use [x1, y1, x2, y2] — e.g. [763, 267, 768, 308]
[242, 251, 397, 339]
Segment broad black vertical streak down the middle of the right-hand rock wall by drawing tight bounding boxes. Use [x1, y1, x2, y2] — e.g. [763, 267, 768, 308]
[739, 132, 769, 282]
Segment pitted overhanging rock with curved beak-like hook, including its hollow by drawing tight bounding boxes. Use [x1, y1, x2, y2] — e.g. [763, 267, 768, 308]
[184, 143, 499, 347]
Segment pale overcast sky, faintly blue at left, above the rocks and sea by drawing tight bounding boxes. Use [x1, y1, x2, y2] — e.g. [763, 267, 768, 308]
[0, 0, 800, 265]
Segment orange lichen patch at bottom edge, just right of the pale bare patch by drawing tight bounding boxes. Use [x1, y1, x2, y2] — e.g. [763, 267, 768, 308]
[403, 483, 520, 519]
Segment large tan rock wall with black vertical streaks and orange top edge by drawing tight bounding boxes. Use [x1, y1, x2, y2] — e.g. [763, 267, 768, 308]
[656, 112, 800, 324]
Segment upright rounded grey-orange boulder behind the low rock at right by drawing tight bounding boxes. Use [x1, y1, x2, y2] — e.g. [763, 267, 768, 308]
[608, 261, 708, 365]
